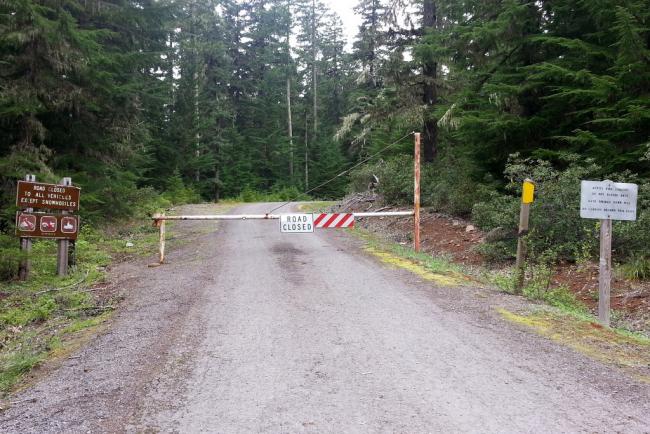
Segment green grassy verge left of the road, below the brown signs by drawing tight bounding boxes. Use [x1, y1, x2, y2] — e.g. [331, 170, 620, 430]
[0, 214, 170, 397]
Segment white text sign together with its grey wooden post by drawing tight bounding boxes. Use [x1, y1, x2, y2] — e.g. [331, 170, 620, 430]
[580, 180, 639, 327]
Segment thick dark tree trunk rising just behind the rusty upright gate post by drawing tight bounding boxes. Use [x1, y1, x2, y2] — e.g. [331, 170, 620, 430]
[422, 0, 438, 162]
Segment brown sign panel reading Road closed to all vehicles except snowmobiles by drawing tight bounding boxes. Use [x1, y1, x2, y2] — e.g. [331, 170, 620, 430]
[16, 181, 81, 211]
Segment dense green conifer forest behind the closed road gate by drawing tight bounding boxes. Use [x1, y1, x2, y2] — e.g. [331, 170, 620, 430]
[0, 0, 650, 259]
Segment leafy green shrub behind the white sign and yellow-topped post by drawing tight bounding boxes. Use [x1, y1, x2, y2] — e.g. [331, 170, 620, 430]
[472, 154, 650, 262]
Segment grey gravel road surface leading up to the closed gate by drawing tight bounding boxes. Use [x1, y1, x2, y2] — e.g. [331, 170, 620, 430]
[0, 204, 650, 433]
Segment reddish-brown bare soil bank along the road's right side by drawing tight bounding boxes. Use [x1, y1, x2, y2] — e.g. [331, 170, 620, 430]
[334, 194, 650, 333]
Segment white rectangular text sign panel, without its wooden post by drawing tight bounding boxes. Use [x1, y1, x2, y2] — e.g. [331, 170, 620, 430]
[580, 181, 639, 221]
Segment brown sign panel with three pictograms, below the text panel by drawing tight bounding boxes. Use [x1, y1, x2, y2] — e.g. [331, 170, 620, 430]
[16, 211, 79, 240]
